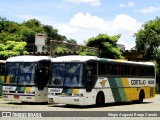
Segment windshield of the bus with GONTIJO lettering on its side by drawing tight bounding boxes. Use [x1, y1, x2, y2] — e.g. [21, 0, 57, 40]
[51, 63, 83, 87]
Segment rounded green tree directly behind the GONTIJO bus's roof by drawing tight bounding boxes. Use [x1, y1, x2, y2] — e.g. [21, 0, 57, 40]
[86, 34, 123, 59]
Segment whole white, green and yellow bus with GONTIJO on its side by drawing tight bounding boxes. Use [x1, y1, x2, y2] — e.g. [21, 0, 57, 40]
[48, 56, 156, 106]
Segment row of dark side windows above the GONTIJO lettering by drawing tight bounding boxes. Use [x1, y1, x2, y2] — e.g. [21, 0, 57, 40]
[98, 62, 155, 77]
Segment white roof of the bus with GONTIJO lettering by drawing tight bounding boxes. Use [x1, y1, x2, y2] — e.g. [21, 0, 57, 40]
[52, 55, 154, 66]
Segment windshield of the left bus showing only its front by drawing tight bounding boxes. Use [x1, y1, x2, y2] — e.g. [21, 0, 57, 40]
[6, 62, 36, 85]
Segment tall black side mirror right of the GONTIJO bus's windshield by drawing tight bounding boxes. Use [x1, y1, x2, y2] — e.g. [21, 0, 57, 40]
[86, 69, 92, 92]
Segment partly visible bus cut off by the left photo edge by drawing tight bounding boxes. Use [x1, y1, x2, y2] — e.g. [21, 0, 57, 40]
[0, 60, 6, 96]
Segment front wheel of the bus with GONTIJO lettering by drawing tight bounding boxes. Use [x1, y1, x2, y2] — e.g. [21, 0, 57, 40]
[96, 92, 105, 106]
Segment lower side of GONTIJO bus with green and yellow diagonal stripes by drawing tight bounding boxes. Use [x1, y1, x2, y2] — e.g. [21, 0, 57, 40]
[95, 77, 155, 102]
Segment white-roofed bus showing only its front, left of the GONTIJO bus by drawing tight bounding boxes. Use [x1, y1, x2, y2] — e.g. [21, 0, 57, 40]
[3, 55, 51, 103]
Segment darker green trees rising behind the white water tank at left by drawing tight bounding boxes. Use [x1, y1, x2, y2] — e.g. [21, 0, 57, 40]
[0, 17, 67, 45]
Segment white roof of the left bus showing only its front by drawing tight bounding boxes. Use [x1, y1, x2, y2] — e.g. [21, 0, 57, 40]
[6, 55, 50, 62]
